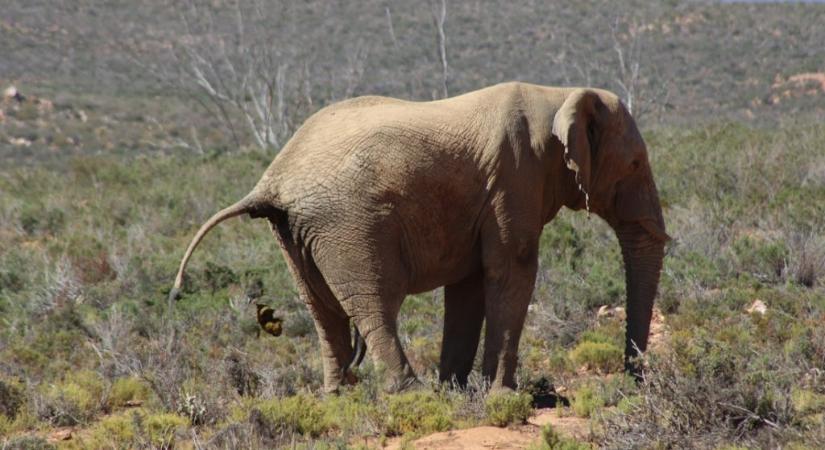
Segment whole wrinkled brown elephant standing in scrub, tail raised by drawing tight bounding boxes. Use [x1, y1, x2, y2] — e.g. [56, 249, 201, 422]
[175, 83, 668, 391]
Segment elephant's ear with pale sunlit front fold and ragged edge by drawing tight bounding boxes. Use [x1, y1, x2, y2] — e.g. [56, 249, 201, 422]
[553, 89, 605, 202]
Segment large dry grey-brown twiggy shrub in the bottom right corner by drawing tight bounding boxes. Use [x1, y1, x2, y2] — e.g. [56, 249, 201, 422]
[600, 333, 808, 448]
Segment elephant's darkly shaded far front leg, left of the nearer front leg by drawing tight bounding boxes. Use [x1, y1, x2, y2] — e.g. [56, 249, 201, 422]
[438, 271, 484, 387]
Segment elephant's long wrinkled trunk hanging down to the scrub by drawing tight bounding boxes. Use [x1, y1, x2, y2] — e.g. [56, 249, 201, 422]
[615, 222, 665, 379]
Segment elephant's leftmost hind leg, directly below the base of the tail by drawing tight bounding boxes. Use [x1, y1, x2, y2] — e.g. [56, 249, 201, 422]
[273, 222, 356, 392]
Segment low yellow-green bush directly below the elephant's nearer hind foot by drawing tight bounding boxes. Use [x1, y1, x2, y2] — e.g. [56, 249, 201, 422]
[385, 391, 453, 436]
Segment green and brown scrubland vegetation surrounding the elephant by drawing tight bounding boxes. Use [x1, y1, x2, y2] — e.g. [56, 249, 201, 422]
[0, 2, 825, 449]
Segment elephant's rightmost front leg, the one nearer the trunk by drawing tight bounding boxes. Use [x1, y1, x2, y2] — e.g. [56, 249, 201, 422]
[482, 239, 538, 389]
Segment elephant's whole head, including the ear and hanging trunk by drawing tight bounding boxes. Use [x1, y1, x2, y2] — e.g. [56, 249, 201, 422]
[553, 89, 670, 376]
